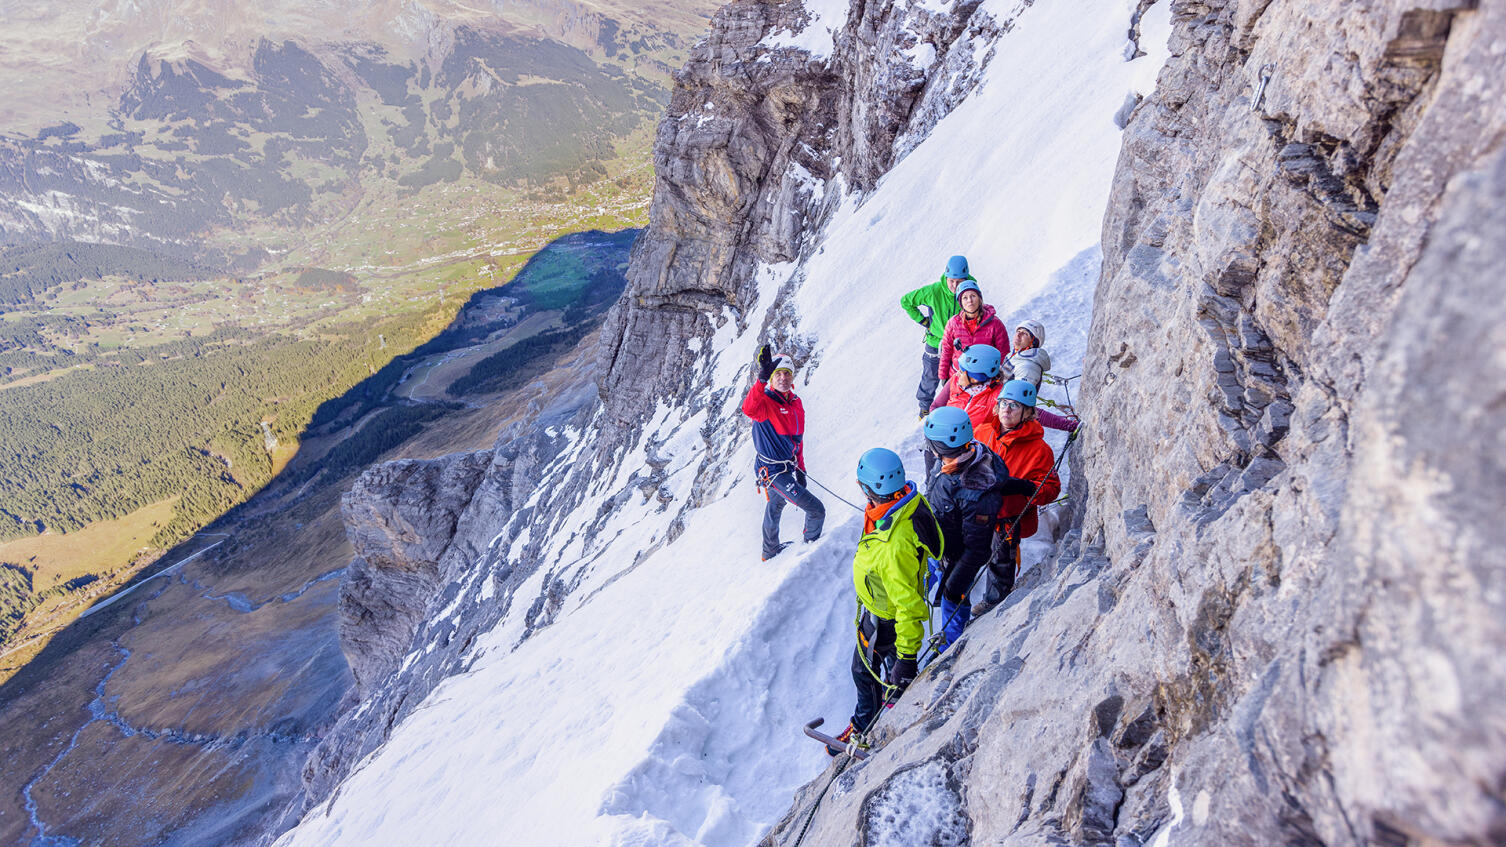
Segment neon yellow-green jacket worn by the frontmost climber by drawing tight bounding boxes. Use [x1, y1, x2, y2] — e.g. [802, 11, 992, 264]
[852, 482, 941, 657]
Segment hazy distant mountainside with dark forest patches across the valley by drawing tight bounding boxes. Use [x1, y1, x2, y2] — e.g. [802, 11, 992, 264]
[0, 3, 705, 256]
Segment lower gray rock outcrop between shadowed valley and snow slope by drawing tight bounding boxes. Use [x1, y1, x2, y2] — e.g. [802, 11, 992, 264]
[296, 345, 595, 801]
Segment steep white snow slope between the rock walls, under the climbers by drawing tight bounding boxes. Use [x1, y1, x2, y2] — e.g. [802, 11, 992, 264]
[280, 0, 1170, 845]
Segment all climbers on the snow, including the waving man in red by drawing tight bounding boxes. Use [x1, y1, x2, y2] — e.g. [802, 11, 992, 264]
[742, 250, 1078, 755]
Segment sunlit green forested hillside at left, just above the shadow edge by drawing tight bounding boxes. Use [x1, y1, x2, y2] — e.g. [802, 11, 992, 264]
[0, 308, 434, 547]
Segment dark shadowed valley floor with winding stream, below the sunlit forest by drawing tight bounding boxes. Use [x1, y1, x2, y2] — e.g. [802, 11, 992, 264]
[0, 231, 637, 844]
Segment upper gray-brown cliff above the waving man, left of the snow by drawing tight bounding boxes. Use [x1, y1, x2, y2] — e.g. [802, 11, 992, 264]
[601, 0, 1008, 425]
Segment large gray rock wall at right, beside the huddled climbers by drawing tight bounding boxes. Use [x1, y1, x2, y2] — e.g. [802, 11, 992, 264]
[768, 0, 1506, 847]
